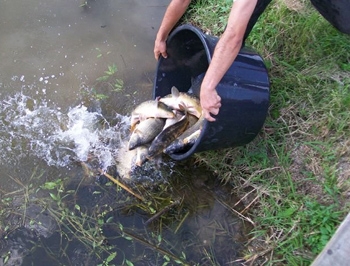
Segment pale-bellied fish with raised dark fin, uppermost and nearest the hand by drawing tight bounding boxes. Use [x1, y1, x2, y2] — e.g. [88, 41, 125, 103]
[159, 86, 202, 118]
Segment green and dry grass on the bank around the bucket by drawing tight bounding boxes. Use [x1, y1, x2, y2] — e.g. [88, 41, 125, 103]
[184, 0, 350, 265]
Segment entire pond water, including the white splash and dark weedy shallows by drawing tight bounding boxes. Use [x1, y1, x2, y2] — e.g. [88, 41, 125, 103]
[0, 0, 252, 265]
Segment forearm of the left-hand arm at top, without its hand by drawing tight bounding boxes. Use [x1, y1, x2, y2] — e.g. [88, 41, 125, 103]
[156, 0, 191, 41]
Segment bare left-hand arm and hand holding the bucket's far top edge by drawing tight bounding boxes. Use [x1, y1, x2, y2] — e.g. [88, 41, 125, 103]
[154, 0, 191, 59]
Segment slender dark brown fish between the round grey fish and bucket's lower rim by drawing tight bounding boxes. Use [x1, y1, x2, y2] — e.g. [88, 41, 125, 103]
[147, 109, 188, 160]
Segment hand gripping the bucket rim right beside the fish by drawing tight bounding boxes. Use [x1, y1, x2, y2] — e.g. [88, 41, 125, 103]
[200, 88, 221, 122]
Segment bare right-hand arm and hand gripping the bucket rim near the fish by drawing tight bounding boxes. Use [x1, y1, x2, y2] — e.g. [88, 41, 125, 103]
[200, 0, 257, 121]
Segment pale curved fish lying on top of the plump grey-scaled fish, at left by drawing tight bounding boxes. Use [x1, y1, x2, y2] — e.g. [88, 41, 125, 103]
[130, 99, 175, 131]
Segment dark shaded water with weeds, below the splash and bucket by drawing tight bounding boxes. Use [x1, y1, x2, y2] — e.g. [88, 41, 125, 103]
[0, 161, 249, 265]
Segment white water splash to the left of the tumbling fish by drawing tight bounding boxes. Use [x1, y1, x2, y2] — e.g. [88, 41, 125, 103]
[0, 93, 129, 169]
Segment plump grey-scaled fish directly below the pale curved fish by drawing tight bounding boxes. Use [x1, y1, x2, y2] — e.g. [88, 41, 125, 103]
[128, 118, 165, 150]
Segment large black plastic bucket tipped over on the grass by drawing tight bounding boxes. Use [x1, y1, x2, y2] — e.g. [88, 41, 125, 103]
[153, 25, 270, 160]
